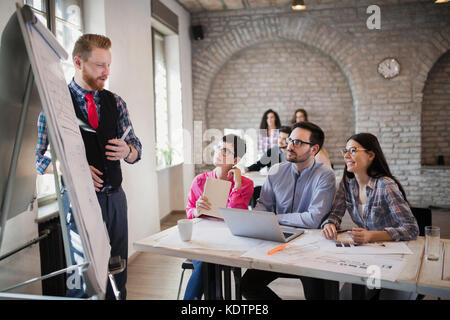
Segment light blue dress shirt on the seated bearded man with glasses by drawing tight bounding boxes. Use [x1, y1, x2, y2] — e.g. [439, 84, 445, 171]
[255, 160, 336, 229]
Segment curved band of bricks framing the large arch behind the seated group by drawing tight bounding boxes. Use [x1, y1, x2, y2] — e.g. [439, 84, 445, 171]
[193, 16, 363, 126]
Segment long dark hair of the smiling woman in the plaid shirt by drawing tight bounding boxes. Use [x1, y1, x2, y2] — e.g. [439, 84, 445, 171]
[342, 133, 408, 201]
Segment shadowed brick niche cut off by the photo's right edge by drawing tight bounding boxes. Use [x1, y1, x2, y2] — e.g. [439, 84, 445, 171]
[422, 52, 450, 165]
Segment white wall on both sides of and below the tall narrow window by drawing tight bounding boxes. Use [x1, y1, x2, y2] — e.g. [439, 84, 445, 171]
[100, 0, 194, 255]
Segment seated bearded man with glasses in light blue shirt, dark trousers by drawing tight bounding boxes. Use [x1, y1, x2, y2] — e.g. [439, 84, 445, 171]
[242, 122, 336, 300]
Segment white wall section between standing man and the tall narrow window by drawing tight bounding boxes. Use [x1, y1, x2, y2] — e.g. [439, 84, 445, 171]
[100, 0, 160, 255]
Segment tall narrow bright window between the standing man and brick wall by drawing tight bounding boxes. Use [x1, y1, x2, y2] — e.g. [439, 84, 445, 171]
[152, 28, 183, 169]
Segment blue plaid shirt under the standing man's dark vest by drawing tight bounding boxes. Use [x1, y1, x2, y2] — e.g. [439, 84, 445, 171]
[36, 79, 142, 174]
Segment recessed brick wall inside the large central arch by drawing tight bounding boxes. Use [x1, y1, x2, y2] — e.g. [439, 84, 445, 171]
[206, 41, 355, 163]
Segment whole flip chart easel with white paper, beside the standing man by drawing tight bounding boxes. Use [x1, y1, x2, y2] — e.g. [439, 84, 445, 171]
[0, 4, 112, 299]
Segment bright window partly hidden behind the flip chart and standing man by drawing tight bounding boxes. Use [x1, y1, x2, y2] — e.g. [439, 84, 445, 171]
[24, 0, 83, 203]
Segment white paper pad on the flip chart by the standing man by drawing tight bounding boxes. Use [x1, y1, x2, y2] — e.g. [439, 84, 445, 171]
[26, 22, 111, 293]
